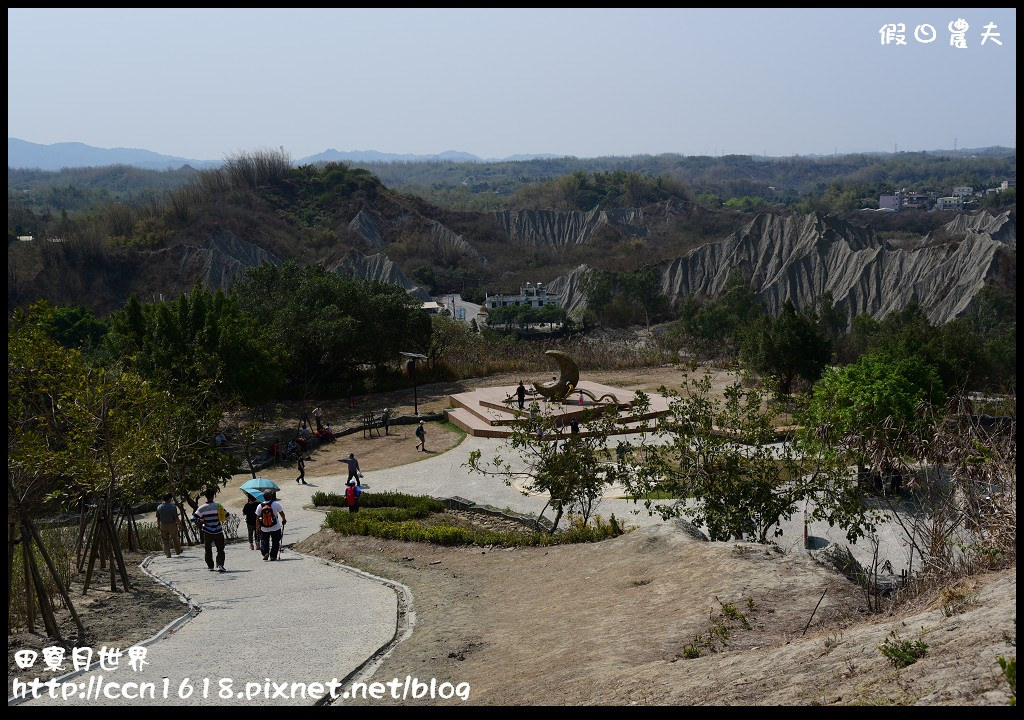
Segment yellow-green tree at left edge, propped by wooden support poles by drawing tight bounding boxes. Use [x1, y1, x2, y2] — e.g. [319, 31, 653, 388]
[8, 301, 169, 590]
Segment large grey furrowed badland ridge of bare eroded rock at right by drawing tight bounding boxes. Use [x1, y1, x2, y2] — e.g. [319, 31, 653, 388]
[549, 211, 1017, 324]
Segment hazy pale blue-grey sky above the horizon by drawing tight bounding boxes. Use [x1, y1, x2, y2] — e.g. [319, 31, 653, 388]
[7, 6, 1017, 160]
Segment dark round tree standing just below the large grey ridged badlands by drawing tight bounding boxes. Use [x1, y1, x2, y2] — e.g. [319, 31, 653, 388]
[741, 300, 833, 395]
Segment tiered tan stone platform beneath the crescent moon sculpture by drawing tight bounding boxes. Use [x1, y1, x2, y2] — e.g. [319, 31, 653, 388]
[445, 380, 669, 437]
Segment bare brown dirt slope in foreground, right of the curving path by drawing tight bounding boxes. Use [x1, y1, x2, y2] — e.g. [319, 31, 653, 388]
[296, 525, 1017, 706]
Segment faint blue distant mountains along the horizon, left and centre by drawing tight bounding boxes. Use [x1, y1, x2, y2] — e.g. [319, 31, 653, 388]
[7, 137, 562, 171]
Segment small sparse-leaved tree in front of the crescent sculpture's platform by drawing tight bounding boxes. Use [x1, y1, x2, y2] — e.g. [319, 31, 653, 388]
[465, 399, 626, 533]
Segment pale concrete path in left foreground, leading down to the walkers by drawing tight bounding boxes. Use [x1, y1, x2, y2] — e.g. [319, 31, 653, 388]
[17, 479, 398, 706]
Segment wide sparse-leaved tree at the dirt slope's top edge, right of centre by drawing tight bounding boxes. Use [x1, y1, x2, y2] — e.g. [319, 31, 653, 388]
[624, 374, 872, 543]
